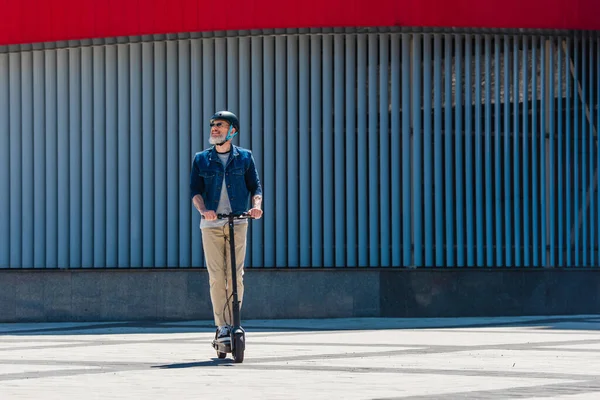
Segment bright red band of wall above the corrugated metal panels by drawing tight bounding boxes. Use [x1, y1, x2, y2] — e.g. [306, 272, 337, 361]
[0, 0, 600, 44]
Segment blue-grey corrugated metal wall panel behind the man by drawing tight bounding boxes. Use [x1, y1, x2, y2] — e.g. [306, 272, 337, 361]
[0, 30, 600, 268]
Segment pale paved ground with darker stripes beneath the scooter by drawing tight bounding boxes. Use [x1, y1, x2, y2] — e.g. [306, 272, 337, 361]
[0, 316, 600, 400]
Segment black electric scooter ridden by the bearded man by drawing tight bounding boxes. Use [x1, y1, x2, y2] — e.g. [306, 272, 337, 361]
[212, 213, 253, 363]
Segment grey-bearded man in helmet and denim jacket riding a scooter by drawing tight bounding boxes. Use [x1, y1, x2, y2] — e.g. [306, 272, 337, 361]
[190, 111, 262, 343]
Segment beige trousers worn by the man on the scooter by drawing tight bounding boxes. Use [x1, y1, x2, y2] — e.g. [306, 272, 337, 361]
[202, 224, 248, 326]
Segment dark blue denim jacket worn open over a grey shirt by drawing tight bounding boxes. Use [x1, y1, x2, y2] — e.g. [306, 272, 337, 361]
[190, 145, 262, 214]
